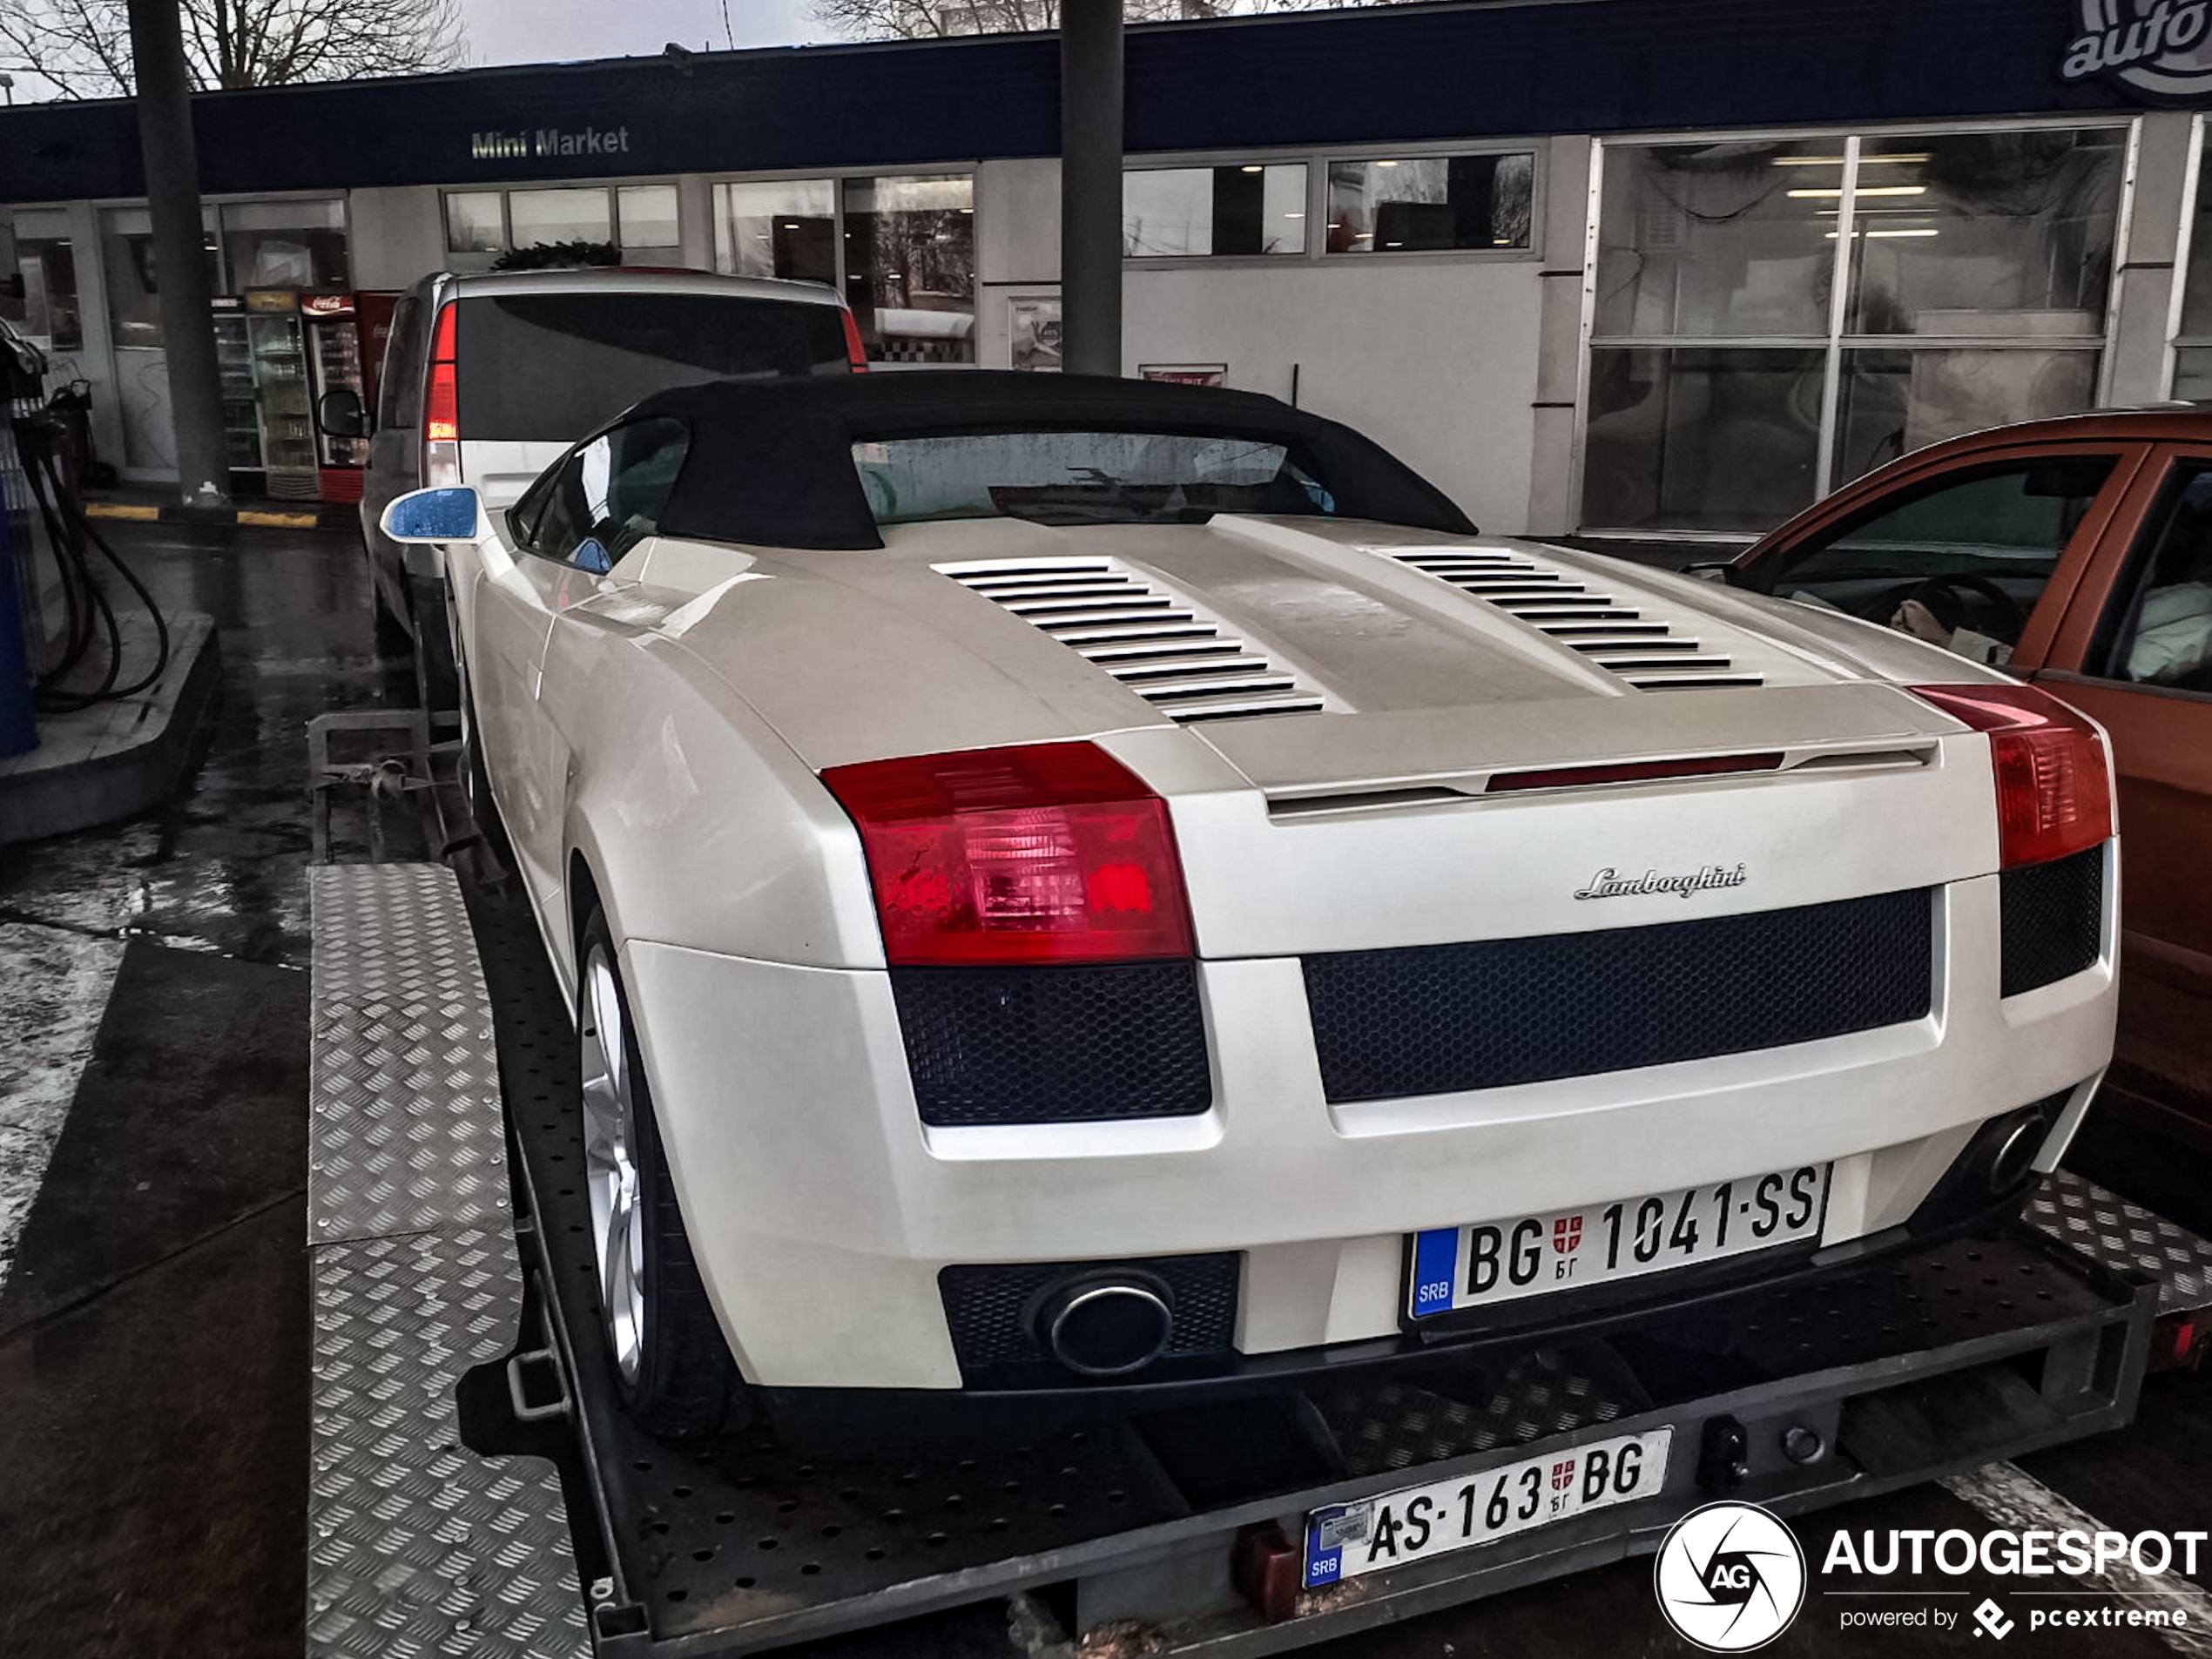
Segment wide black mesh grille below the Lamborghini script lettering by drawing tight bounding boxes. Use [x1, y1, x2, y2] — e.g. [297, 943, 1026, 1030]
[1305, 887, 1933, 1099]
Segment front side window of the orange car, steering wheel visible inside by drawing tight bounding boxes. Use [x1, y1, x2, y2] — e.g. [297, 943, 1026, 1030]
[1754, 454, 2119, 661]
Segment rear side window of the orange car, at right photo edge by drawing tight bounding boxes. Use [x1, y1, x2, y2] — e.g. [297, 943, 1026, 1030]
[2088, 460, 2212, 692]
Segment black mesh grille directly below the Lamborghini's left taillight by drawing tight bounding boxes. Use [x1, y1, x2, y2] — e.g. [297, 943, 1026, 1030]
[892, 962, 1214, 1126]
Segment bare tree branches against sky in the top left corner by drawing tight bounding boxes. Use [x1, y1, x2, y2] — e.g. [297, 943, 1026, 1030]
[0, 0, 462, 98]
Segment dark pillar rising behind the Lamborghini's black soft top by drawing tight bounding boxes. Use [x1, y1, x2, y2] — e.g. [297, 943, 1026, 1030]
[1060, 0, 1122, 374]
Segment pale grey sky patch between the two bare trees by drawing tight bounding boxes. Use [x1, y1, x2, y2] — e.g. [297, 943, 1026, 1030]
[462, 0, 839, 66]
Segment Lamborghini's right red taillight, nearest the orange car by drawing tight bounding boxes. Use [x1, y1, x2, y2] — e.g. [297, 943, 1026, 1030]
[1912, 685, 2113, 869]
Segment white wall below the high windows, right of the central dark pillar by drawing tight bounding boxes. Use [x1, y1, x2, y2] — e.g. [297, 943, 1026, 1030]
[1122, 254, 1540, 533]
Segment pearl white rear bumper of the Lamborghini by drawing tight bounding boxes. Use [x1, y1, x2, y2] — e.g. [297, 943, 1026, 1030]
[624, 858, 2113, 1389]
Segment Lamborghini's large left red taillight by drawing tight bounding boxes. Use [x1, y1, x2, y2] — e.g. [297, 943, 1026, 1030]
[823, 743, 1192, 967]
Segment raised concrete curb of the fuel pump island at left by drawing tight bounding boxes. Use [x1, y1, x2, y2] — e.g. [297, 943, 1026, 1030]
[0, 613, 221, 843]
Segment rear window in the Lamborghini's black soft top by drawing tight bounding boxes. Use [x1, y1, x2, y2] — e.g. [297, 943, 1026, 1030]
[852, 431, 1336, 524]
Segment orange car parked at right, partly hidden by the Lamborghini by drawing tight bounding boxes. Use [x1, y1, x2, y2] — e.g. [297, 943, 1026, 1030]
[1725, 405, 2212, 1148]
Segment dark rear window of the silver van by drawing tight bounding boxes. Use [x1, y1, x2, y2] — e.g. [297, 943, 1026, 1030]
[455, 292, 852, 442]
